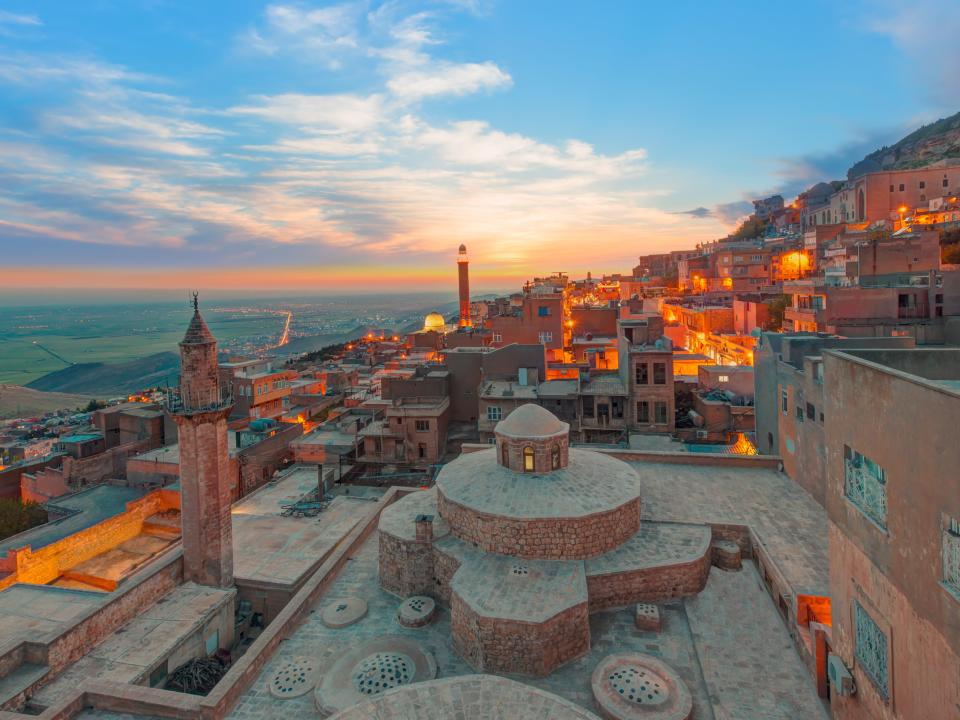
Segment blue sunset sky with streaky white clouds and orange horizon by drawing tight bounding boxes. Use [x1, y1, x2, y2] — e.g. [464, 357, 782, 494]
[0, 0, 960, 296]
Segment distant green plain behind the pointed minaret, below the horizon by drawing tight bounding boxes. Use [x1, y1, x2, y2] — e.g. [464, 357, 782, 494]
[0, 304, 283, 385]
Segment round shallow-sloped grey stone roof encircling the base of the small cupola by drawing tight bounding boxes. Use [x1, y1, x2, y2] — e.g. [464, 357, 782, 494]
[437, 448, 639, 518]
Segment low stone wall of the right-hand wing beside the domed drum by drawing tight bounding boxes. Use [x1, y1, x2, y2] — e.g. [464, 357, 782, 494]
[587, 546, 711, 612]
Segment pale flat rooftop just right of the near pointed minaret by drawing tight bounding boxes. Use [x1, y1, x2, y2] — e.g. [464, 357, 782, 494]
[233, 467, 380, 586]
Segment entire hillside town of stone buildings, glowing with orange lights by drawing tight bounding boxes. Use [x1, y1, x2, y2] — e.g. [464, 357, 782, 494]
[0, 162, 960, 720]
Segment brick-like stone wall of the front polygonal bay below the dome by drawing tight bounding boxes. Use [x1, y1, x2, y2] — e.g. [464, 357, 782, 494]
[450, 593, 590, 677]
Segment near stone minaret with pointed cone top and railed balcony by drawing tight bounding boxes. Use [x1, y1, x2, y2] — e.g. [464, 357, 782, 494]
[168, 293, 233, 588]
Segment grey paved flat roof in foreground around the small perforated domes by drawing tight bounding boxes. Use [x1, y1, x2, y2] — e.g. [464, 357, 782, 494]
[225, 535, 827, 720]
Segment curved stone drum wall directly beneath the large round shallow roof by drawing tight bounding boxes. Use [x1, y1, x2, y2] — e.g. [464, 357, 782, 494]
[437, 491, 640, 560]
